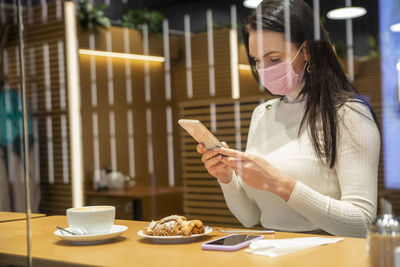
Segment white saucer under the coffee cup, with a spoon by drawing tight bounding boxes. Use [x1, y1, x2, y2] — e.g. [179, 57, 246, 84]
[54, 225, 128, 244]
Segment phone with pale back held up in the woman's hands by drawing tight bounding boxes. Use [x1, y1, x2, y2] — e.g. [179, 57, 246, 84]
[178, 119, 223, 150]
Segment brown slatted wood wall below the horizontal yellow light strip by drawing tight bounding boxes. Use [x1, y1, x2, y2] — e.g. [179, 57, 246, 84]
[79, 27, 181, 195]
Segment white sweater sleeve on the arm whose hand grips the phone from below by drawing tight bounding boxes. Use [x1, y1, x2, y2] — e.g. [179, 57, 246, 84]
[220, 103, 261, 227]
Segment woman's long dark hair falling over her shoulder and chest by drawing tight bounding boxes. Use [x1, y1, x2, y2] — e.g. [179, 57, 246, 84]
[243, 0, 378, 168]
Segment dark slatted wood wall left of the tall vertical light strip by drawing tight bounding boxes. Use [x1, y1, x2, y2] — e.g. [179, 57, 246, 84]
[6, 1, 72, 215]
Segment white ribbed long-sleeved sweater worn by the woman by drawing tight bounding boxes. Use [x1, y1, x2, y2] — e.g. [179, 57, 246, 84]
[220, 99, 380, 237]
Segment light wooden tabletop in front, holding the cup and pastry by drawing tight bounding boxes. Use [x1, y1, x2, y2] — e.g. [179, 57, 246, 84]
[0, 216, 368, 267]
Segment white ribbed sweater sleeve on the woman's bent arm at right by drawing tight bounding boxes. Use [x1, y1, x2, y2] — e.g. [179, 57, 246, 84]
[287, 103, 380, 237]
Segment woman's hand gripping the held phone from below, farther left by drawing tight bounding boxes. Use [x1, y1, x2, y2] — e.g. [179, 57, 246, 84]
[197, 142, 233, 184]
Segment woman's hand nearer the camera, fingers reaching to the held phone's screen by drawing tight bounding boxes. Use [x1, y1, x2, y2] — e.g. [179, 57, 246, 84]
[216, 147, 296, 201]
